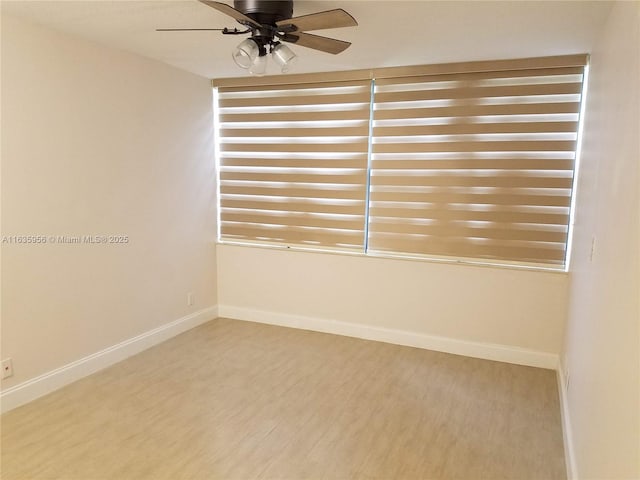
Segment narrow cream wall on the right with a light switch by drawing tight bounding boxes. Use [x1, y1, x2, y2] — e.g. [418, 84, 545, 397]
[564, 2, 640, 479]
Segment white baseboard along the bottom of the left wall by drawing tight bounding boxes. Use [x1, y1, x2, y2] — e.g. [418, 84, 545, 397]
[0, 306, 218, 413]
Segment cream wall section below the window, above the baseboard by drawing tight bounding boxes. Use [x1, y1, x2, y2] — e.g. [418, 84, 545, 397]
[218, 245, 567, 354]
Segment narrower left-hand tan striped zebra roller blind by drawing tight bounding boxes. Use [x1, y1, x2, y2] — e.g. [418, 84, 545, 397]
[218, 81, 371, 251]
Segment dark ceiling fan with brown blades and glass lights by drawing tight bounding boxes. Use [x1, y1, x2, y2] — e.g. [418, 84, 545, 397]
[157, 0, 358, 75]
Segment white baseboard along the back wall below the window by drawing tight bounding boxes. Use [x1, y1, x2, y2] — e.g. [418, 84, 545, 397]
[218, 305, 558, 370]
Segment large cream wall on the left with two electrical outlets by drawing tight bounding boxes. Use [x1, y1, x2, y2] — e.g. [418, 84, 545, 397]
[2, 15, 216, 388]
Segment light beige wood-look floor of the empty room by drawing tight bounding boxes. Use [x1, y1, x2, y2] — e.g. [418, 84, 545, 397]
[1, 319, 565, 480]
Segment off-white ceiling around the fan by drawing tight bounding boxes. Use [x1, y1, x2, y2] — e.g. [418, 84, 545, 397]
[2, 0, 611, 78]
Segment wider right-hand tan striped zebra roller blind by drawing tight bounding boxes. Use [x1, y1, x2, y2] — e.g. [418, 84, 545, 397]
[369, 67, 583, 264]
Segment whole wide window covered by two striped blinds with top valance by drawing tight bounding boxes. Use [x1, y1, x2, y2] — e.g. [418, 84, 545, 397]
[214, 55, 587, 268]
